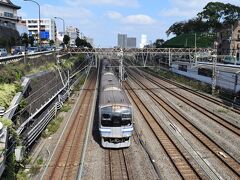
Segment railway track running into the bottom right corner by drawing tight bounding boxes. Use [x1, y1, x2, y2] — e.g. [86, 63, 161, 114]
[126, 71, 240, 178]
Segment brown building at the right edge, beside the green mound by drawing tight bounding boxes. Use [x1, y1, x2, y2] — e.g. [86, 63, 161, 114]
[218, 21, 240, 59]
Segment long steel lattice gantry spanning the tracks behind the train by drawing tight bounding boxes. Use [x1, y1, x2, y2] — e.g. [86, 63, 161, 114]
[62, 48, 214, 67]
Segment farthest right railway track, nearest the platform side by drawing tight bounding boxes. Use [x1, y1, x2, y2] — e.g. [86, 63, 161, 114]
[144, 68, 240, 114]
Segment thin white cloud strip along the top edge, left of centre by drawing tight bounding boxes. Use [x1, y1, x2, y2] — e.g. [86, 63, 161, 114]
[65, 0, 139, 7]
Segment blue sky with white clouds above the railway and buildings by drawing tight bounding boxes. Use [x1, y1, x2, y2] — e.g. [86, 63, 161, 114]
[12, 0, 240, 47]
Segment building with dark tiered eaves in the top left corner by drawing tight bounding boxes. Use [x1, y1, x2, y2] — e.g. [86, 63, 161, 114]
[0, 0, 21, 30]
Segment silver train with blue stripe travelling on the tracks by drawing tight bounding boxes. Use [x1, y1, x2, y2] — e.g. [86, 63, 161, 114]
[99, 59, 133, 148]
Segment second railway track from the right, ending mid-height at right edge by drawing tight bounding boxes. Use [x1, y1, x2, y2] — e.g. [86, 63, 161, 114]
[132, 69, 240, 136]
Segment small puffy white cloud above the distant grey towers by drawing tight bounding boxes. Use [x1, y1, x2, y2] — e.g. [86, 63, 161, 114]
[106, 11, 156, 25]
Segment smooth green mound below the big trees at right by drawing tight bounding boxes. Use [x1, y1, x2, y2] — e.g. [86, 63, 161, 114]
[163, 33, 216, 48]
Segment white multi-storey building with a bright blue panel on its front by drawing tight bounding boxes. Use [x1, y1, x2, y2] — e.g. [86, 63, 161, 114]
[21, 18, 57, 43]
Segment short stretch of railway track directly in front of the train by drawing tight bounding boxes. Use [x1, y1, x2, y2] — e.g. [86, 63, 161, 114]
[105, 149, 134, 180]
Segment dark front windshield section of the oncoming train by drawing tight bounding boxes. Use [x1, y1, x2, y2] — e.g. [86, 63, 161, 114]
[101, 106, 132, 127]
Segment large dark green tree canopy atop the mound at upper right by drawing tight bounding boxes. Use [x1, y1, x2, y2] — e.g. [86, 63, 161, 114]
[166, 2, 240, 36]
